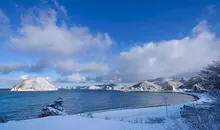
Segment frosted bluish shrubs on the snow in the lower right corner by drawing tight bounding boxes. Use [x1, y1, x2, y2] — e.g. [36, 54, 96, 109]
[180, 91, 220, 130]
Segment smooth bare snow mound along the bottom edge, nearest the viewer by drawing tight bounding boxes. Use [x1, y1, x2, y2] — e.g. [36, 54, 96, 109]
[0, 115, 158, 130]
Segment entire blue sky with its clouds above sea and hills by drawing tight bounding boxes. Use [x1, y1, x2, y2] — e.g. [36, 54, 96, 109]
[0, 0, 220, 86]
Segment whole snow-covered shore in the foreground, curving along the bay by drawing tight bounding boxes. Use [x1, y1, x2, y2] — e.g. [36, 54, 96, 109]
[0, 94, 211, 130]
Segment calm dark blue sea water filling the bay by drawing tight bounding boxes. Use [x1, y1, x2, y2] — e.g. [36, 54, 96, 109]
[0, 90, 195, 120]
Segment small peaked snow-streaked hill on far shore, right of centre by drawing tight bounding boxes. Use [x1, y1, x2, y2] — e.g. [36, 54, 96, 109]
[132, 81, 162, 91]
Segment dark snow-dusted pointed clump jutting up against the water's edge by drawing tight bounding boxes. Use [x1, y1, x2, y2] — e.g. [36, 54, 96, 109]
[39, 98, 66, 117]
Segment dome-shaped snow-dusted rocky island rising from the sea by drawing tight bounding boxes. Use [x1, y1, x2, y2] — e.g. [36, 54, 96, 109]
[11, 78, 58, 91]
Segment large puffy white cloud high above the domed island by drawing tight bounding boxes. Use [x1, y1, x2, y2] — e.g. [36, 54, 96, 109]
[10, 9, 112, 55]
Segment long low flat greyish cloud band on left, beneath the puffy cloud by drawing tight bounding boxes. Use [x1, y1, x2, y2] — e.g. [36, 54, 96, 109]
[0, 59, 109, 75]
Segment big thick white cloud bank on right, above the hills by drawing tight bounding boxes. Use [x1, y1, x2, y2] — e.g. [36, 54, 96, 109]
[118, 21, 220, 80]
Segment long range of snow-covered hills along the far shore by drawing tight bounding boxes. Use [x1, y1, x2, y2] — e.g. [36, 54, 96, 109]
[57, 77, 205, 92]
